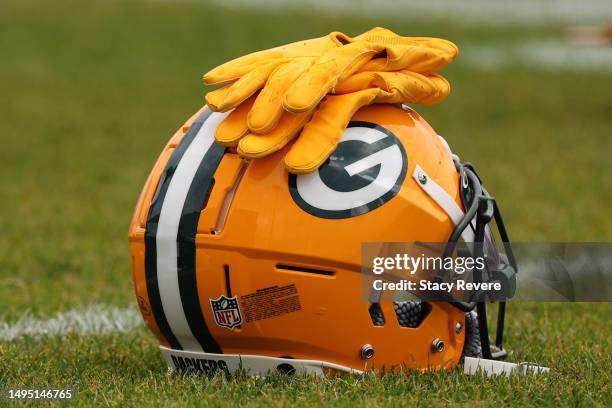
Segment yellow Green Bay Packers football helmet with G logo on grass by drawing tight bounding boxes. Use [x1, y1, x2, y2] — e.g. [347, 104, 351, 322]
[129, 104, 516, 374]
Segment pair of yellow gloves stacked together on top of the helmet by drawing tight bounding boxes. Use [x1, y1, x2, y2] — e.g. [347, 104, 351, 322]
[204, 28, 458, 173]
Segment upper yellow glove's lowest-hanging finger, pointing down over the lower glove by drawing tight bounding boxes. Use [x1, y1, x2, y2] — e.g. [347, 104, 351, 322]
[247, 58, 313, 133]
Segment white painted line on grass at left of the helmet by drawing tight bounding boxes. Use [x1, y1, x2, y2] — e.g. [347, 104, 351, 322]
[0, 305, 144, 341]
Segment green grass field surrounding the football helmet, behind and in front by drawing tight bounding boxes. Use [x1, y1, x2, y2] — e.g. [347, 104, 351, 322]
[0, 0, 612, 407]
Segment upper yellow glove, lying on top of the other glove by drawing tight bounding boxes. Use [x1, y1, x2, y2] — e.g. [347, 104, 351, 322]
[204, 28, 458, 133]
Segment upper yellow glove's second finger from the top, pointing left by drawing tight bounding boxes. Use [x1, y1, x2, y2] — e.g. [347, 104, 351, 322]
[206, 59, 286, 112]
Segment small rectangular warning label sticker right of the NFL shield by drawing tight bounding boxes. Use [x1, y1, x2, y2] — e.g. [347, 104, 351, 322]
[240, 284, 302, 322]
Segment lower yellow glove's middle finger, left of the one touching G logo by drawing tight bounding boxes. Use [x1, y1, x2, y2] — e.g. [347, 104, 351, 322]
[238, 112, 312, 159]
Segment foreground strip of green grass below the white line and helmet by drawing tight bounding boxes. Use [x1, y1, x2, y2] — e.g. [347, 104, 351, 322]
[0, 304, 612, 406]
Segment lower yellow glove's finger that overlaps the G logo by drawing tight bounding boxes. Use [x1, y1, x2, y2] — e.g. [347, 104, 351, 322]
[285, 89, 379, 174]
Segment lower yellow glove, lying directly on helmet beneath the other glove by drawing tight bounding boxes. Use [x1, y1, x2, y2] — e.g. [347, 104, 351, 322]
[215, 70, 450, 173]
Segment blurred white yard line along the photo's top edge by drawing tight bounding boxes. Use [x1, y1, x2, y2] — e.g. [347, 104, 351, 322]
[201, 0, 612, 25]
